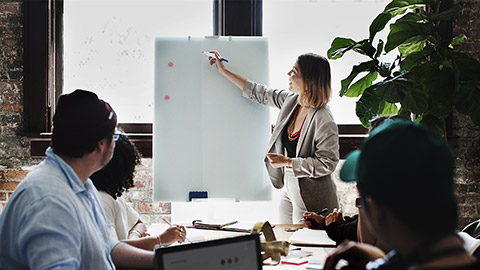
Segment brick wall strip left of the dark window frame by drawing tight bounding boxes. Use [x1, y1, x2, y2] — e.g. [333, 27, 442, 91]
[0, 1, 38, 209]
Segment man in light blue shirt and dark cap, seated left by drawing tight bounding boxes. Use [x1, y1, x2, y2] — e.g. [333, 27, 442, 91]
[0, 90, 154, 270]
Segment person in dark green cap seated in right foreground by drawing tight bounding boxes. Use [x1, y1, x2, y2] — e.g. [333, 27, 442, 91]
[324, 120, 480, 270]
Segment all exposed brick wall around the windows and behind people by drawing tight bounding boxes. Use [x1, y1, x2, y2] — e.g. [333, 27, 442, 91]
[0, 0, 480, 227]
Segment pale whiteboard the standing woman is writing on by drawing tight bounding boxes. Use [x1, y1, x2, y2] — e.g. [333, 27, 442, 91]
[153, 37, 271, 201]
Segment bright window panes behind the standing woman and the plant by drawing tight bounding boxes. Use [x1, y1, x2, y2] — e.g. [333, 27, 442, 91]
[263, 0, 390, 125]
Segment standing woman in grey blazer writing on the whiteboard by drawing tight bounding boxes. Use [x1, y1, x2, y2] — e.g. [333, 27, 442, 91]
[210, 51, 339, 224]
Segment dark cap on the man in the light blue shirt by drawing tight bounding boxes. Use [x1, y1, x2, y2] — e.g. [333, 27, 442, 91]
[52, 89, 117, 156]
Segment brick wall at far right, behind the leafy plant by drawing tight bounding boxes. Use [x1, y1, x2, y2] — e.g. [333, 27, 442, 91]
[449, 0, 480, 228]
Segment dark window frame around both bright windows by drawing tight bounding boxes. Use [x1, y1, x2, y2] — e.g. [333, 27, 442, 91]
[23, 0, 367, 158]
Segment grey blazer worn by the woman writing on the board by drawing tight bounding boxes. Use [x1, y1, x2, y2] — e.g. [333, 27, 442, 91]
[243, 81, 339, 212]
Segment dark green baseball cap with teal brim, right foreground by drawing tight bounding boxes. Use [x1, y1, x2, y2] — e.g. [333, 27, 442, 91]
[340, 120, 454, 204]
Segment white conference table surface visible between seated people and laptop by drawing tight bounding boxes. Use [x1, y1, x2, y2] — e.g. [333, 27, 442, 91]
[148, 224, 335, 270]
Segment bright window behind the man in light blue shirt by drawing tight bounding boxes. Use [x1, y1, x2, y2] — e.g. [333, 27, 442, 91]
[63, 0, 213, 123]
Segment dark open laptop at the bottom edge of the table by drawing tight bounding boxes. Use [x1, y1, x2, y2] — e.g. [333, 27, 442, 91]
[155, 234, 262, 270]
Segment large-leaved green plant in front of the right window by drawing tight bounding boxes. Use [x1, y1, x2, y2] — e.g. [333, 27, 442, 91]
[327, 0, 480, 135]
